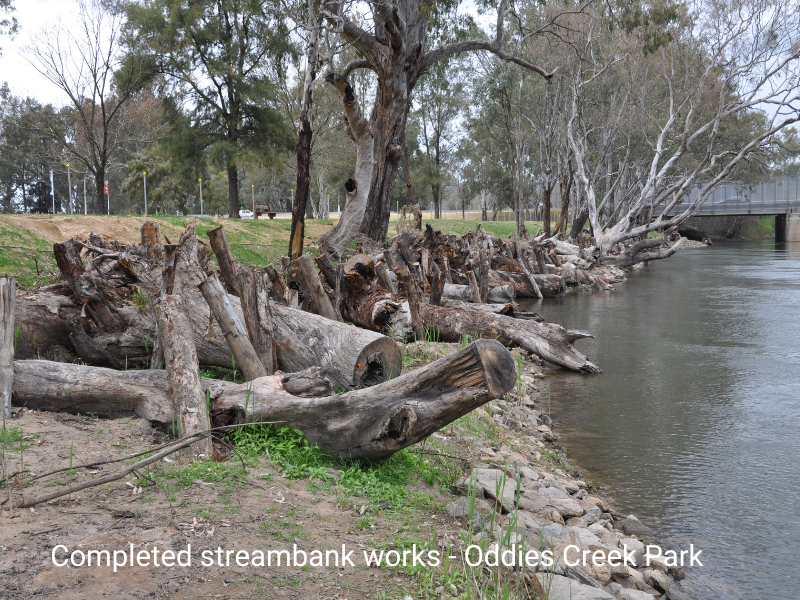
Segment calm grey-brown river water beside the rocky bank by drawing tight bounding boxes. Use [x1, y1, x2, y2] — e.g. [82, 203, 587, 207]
[520, 242, 800, 600]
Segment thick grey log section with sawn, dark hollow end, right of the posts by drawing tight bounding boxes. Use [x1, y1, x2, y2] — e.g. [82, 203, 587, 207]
[272, 305, 403, 388]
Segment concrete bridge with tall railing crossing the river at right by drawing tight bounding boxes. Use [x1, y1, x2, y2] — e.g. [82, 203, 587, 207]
[669, 176, 800, 242]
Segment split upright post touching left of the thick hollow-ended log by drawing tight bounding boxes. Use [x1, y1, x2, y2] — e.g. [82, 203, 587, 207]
[236, 269, 278, 375]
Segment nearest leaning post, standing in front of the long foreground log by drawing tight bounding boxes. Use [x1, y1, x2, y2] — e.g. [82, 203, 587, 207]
[157, 295, 211, 458]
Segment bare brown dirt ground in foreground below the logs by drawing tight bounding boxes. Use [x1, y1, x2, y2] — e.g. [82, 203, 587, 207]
[0, 410, 459, 600]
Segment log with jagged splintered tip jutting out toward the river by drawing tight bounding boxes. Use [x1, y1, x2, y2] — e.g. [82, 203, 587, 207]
[412, 304, 600, 373]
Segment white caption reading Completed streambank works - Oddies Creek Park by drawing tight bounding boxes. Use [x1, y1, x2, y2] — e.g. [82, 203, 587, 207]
[51, 544, 702, 573]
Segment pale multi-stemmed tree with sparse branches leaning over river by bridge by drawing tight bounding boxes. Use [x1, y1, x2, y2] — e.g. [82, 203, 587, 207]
[567, 0, 800, 262]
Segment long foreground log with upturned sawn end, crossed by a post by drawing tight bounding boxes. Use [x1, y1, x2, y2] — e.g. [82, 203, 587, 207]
[14, 340, 516, 460]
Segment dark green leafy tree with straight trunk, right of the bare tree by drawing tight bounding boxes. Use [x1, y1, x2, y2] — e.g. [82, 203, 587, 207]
[125, 0, 296, 218]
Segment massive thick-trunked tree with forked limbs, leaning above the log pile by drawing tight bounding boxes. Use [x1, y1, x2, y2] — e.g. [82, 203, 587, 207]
[321, 0, 560, 254]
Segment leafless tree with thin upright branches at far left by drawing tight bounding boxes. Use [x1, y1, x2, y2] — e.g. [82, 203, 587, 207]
[25, 0, 142, 213]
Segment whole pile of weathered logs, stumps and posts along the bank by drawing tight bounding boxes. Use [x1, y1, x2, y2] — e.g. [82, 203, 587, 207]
[0, 223, 599, 459]
